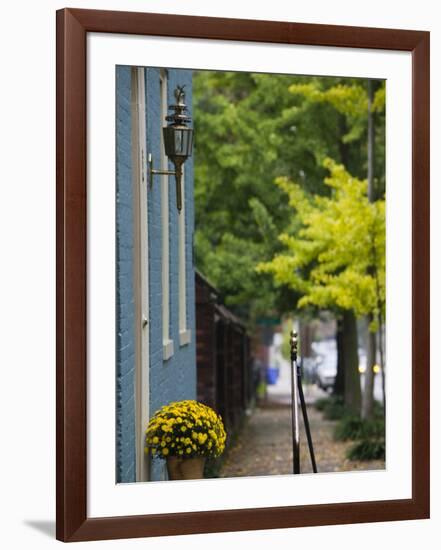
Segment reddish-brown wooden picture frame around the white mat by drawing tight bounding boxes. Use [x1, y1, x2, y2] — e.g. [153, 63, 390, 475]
[56, 9, 429, 542]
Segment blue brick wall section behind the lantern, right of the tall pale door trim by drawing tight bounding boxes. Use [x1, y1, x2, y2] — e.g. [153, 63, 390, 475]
[146, 69, 196, 479]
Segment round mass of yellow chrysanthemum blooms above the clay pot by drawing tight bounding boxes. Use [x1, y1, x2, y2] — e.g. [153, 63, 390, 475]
[145, 400, 227, 458]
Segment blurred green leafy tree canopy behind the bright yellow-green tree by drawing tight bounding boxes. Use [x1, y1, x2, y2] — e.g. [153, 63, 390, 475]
[194, 71, 381, 326]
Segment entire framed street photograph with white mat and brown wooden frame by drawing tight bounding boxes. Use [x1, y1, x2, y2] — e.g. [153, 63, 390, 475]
[57, 9, 429, 542]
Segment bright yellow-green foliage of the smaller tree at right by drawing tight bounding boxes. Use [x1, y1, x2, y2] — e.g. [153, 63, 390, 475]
[258, 159, 385, 329]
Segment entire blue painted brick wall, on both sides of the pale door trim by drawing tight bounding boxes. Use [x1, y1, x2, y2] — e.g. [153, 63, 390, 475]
[116, 67, 196, 482]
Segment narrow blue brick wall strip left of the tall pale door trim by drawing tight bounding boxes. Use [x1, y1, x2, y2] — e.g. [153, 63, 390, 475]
[116, 67, 135, 482]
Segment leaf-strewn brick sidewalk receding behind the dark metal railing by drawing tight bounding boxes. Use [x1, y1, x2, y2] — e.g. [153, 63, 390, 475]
[220, 362, 384, 477]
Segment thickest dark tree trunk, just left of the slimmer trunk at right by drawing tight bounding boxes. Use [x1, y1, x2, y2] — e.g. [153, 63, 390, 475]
[343, 310, 361, 414]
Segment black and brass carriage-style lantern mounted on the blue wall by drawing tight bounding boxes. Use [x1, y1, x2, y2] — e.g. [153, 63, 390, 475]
[148, 86, 193, 212]
